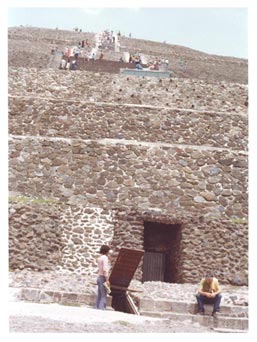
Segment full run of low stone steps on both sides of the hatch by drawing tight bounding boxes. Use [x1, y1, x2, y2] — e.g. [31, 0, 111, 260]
[11, 288, 248, 333]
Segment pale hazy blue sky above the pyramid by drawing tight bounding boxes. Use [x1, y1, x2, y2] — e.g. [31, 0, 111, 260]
[8, 7, 248, 58]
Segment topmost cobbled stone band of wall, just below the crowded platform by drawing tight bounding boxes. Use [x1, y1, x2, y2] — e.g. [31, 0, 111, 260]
[9, 68, 248, 114]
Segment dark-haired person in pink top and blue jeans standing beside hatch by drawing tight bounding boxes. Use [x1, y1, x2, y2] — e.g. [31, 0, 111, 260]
[95, 245, 110, 310]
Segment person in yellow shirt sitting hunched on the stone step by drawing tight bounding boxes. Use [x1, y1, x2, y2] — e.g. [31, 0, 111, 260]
[196, 275, 222, 317]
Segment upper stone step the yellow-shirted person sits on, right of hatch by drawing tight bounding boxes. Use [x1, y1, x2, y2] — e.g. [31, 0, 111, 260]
[139, 299, 248, 318]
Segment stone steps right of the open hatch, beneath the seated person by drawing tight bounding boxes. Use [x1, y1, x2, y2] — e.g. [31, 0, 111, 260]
[139, 299, 248, 332]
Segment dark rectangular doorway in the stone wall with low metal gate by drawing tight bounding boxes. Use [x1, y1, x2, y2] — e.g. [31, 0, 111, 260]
[143, 221, 181, 283]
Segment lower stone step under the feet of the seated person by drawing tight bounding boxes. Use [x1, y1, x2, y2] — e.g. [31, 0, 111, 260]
[140, 311, 248, 331]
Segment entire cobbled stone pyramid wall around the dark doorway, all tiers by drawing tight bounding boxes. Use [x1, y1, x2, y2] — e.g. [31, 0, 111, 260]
[9, 28, 248, 285]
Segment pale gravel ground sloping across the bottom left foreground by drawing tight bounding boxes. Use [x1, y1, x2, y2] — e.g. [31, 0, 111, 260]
[9, 302, 213, 333]
